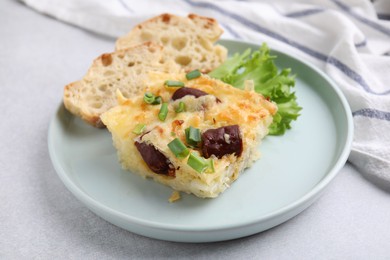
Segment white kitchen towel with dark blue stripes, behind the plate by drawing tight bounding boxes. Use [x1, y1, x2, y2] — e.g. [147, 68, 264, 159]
[23, 0, 390, 190]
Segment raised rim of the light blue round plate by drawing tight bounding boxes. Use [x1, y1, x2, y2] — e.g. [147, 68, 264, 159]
[47, 39, 354, 236]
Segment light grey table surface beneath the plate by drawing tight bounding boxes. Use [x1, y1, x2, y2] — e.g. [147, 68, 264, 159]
[0, 0, 390, 259]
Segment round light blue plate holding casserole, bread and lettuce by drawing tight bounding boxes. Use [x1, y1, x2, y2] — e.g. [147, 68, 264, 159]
[48, 40, 353, 242]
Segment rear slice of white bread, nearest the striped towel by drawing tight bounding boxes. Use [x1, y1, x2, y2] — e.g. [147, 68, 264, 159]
[116, 14, 227, 73]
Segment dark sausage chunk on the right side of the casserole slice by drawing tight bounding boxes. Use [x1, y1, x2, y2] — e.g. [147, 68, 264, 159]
[202, 125, 243, 158]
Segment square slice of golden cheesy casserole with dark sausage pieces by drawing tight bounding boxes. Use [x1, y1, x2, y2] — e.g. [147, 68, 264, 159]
[101, 73, 277, 198]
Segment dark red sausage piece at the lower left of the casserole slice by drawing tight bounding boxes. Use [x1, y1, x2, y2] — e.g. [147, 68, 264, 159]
[134, 141, 175, 177]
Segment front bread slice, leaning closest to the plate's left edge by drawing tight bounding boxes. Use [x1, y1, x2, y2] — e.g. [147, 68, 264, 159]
[64, 42, 182, 127]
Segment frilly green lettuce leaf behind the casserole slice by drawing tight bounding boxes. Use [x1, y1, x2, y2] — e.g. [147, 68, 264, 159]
[209, 43, 302, 135]
